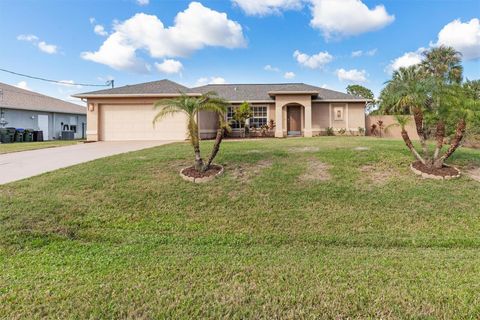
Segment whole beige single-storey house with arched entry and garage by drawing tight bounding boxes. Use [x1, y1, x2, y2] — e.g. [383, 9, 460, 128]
[74, 80, 367, 141]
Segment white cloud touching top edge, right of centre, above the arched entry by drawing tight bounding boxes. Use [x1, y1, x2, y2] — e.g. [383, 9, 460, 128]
[310, 0, 395, 39]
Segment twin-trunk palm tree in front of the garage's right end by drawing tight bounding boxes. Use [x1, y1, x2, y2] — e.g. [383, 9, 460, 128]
[153, 92, 228, 172]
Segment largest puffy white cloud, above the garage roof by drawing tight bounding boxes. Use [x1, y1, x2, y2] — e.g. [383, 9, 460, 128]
[81, 2, 246, 71]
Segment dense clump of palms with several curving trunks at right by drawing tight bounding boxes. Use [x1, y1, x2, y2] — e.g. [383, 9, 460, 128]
[381, 47, 478, 168]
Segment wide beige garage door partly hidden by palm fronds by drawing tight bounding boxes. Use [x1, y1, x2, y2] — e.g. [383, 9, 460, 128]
[100, 104, 187, 141]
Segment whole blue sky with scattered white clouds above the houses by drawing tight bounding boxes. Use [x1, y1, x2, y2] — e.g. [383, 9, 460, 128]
[0, 0, 480, 104]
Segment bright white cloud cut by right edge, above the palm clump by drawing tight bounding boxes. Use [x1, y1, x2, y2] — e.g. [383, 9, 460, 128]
[435, 18, 480, 60]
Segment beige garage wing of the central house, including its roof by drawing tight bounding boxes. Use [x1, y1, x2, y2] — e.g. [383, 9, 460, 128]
[74, 80, 198, 141]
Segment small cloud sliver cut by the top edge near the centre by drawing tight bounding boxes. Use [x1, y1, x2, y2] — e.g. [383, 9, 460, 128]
[232, 0, 303, 16]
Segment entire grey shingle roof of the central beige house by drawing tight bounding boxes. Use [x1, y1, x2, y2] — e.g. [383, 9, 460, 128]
[74, 80, 365, 101]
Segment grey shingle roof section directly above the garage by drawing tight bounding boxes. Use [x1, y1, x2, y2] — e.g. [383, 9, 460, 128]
[75, 79, 190, 97]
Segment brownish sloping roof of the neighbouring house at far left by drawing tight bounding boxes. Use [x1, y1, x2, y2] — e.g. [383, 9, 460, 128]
[0, 82, 87, 114]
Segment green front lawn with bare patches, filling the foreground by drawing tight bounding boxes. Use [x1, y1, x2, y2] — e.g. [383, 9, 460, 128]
[0, 137, 480, 319]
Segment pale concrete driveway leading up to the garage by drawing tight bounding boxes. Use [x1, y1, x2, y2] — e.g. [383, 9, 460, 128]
[0, 141, 174, 184]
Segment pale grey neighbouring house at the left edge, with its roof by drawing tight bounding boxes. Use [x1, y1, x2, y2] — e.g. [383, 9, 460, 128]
[0, 83, 87, 140]
